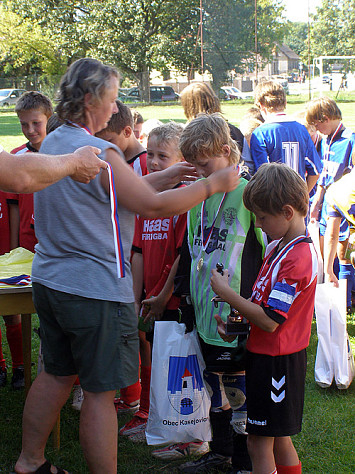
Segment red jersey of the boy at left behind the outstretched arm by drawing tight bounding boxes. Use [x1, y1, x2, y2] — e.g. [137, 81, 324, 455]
[7, 143, 37, 252]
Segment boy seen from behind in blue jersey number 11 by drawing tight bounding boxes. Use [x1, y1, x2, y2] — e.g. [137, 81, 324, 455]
[250, 81, 322, 191]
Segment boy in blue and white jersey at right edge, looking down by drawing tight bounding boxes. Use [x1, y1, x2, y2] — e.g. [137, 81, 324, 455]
[306, 97, 355, 310]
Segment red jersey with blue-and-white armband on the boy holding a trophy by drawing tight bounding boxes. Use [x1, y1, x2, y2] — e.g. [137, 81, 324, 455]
[247, 236, 318, 356]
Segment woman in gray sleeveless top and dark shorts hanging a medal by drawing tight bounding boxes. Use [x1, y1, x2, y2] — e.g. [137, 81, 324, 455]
[15, 58, 238, 474]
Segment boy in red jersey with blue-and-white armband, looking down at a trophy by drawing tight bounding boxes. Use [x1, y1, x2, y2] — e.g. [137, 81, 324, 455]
[211, 163, 317, 474]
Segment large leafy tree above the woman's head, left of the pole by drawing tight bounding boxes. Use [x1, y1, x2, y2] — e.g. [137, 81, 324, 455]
[85, 0, 198, 99]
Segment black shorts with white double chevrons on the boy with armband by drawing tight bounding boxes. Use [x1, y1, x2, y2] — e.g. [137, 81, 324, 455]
[246, 349, 307, 437]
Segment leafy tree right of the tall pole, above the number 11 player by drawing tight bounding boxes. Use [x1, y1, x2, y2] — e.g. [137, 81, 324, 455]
[203, 0, 283, 90]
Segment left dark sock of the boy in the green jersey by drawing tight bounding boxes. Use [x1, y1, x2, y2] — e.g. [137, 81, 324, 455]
[210, 408, 233, 457]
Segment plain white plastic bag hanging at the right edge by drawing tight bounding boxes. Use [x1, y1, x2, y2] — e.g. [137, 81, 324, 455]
[315, 280, 355, 389]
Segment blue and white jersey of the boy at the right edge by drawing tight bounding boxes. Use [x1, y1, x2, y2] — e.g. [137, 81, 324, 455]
[318, 127, 355, 188]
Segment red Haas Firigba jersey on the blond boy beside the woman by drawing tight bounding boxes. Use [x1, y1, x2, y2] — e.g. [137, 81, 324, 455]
[133, 207, 186, 309]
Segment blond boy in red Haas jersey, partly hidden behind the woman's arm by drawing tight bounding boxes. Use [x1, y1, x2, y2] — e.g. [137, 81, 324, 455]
[120, 122, 208, 457]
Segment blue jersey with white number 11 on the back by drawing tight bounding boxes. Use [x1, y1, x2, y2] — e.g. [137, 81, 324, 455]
[250, 114, 322, 179]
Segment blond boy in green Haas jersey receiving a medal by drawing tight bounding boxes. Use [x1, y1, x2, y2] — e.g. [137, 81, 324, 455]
[180, 113, 263, 473]
